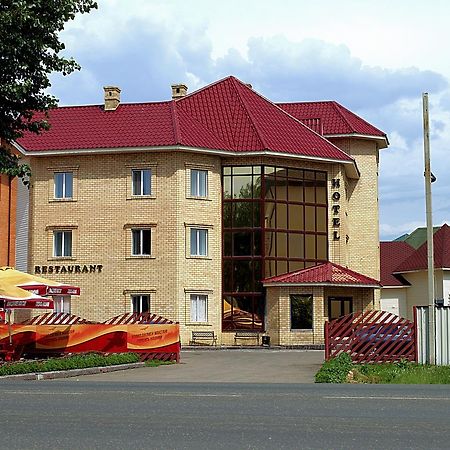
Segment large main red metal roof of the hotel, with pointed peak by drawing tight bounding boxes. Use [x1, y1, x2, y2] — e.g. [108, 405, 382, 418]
[18, 77, 353, 161]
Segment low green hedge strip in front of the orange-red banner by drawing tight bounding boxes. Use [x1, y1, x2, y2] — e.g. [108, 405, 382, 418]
[0, 353, 139, 376]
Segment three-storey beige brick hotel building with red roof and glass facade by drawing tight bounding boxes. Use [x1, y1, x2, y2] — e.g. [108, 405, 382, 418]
[16, 77, 388, 346]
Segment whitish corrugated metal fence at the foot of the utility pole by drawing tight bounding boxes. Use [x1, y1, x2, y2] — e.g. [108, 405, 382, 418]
[415, 306, 450, 366]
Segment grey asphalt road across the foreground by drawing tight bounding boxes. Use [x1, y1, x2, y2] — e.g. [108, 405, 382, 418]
[0, 379, 450, 449]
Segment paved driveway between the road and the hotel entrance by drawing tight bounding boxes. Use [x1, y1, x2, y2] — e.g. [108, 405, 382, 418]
[76, 350, 324, 383]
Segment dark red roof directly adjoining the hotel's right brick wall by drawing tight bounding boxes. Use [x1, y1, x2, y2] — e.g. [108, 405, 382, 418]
[380, 241, 415, 286]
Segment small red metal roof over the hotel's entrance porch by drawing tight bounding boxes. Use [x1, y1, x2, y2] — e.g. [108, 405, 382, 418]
[263, 262, 380, 287]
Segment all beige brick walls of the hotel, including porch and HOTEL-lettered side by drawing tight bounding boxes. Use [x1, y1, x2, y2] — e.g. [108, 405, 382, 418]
[25, 140, 379, 345]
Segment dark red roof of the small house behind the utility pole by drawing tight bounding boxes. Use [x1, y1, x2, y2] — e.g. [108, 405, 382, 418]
[393, 224, 450, 273]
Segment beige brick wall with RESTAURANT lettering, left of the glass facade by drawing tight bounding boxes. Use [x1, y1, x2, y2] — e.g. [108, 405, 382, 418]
[25, 149, 221, 342]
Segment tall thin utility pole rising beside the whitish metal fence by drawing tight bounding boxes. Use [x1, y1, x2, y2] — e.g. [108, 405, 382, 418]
[422, 93, 436, 365]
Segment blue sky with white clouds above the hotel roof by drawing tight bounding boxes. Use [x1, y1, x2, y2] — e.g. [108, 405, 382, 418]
[47, 0, 450, 240]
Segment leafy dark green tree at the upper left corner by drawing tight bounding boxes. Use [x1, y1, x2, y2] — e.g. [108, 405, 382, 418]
[0, 0, 97, 179]
